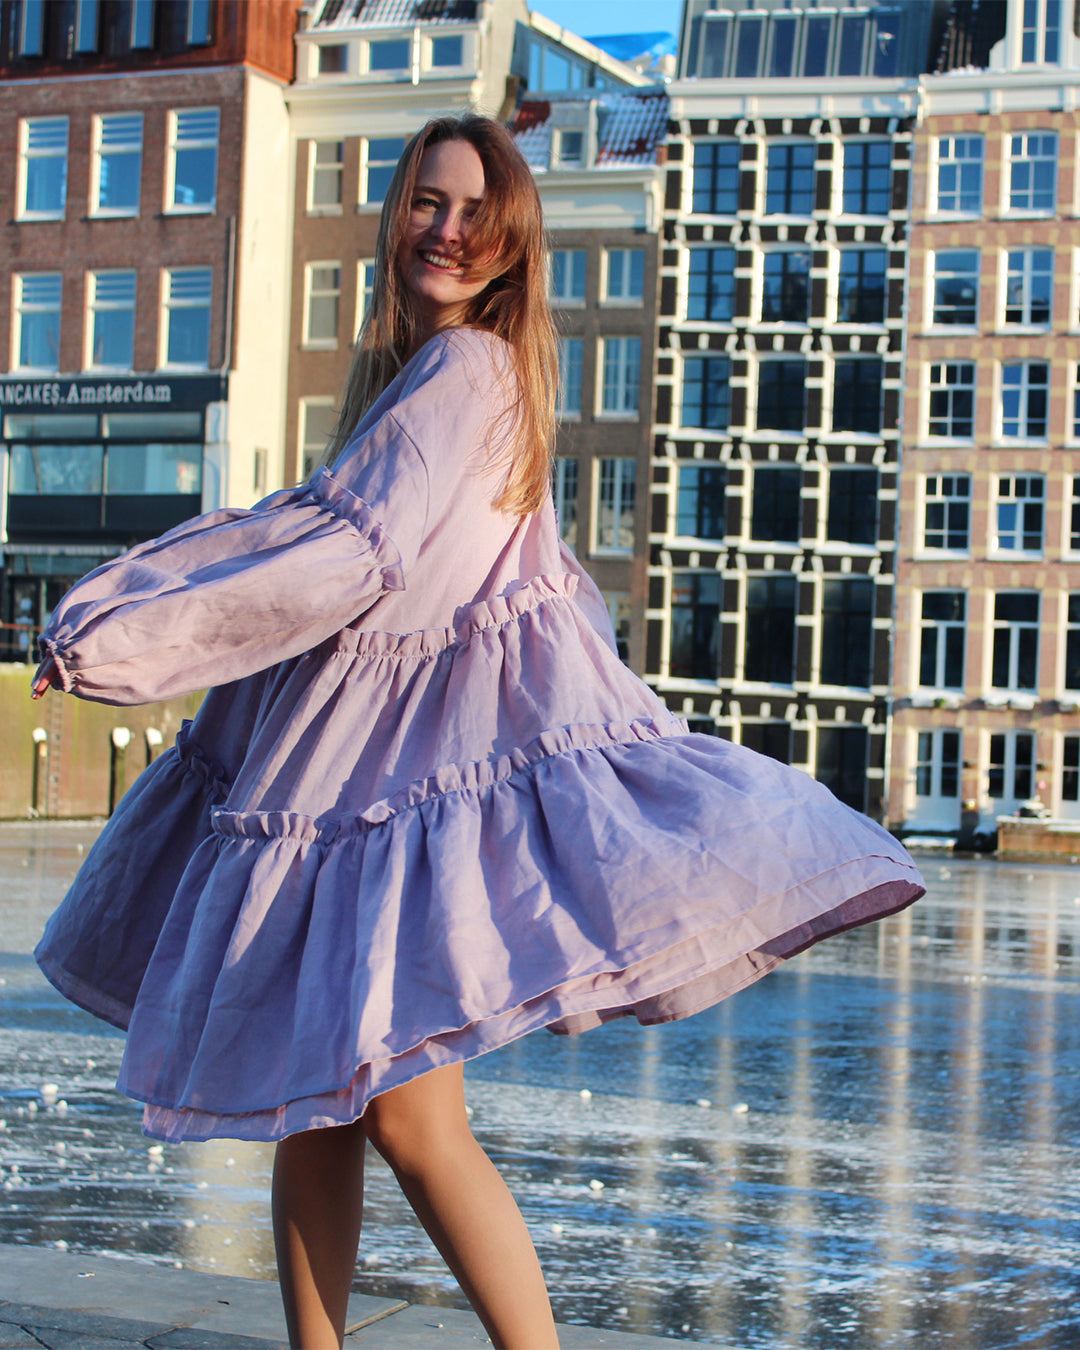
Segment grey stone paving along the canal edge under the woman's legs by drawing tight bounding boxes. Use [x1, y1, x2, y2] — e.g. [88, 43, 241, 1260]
[0, 1245, 679, 1350]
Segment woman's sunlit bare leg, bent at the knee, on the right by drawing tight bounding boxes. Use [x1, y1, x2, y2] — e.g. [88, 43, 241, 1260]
[363, 1064, 559, 1350]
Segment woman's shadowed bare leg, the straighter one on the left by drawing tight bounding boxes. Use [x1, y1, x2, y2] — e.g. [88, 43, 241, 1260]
[273, 1121, 365, 1350]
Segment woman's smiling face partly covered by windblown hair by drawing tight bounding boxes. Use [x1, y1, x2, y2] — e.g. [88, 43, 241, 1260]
[397, 140, 490, 340]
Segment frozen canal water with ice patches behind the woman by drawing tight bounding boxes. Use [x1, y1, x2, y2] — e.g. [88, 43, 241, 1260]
[0, 824, 1080, 1350]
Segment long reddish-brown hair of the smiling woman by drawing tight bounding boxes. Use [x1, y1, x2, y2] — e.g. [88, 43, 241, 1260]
[327, 112, 559, 516]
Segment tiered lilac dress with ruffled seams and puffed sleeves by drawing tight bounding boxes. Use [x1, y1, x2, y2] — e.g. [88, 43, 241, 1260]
[36, 329, 922, 1139]
